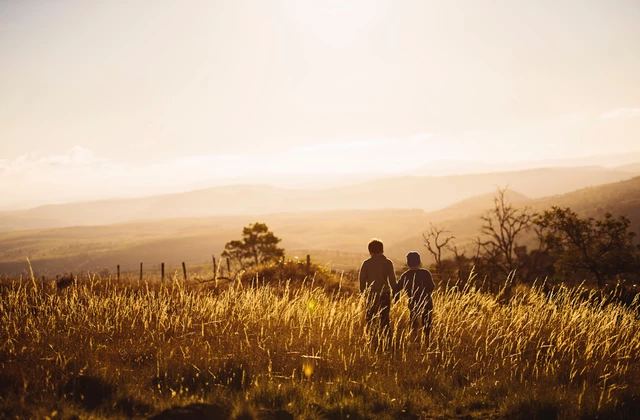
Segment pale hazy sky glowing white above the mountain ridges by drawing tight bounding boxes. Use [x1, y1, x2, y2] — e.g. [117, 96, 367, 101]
[0, 0, 640, 208]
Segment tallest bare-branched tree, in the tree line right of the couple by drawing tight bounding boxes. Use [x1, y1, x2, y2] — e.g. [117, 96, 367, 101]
[477, 187, 536, 274]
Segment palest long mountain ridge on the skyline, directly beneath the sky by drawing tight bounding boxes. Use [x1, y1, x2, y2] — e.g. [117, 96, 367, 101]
[0, 166, 635, 232]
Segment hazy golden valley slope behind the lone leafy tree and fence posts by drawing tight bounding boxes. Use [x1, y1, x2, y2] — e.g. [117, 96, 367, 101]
[0, 210, 436, 275]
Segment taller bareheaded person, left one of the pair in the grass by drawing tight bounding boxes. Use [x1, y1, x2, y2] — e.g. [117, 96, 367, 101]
[359, 239, 397, 347]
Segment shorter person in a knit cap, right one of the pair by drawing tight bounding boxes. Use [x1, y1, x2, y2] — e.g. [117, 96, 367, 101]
[396, 252, 436, 341]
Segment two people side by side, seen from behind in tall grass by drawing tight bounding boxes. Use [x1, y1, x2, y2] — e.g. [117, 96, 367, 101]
[359, 239, 435, 344]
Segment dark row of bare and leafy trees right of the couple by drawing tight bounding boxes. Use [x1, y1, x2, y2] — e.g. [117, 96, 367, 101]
[423, 188, 640, 289]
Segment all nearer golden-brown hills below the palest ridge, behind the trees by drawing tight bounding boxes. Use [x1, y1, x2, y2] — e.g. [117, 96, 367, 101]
[0, 177, 640, 274]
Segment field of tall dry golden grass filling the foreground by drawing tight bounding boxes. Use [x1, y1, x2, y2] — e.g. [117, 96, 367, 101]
[0, 268, 640, 419]
